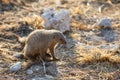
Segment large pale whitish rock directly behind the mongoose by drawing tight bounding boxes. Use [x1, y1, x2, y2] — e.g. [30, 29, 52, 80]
[42, 8, 71, 32]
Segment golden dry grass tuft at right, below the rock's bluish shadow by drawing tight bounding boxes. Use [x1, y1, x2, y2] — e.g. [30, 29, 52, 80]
[77, 49, 120, 64]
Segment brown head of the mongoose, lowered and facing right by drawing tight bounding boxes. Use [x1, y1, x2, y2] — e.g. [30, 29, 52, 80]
[53, 31, 67, 44]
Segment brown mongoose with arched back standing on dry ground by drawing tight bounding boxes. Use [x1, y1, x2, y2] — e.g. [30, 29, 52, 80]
[23, 29, 66, 62]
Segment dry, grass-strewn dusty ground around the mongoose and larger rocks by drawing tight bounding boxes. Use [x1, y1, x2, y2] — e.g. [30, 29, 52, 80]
[0, 0, 120, 80]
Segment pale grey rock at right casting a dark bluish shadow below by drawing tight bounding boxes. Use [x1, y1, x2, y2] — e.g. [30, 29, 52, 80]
[98, 18, 112, 28]
